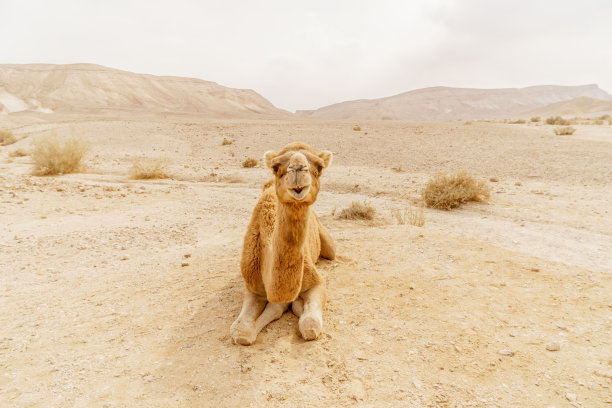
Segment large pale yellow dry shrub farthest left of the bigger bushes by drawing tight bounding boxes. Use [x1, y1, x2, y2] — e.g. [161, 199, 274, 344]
[32, 135, 89, 176]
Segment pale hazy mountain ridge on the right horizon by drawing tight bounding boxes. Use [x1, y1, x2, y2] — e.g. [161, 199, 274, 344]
[296, 84, 612, 120]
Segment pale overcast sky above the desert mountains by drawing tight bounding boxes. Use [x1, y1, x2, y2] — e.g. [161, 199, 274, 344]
[0, 0, 612, 111]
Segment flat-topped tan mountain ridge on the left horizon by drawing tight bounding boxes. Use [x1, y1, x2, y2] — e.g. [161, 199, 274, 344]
[0, 64, 291, 117]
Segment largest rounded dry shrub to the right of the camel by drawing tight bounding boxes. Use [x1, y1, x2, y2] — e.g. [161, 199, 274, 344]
[421, 172, 491, 210]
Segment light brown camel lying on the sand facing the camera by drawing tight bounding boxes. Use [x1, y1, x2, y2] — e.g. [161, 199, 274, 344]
[230, 142, 336, 345]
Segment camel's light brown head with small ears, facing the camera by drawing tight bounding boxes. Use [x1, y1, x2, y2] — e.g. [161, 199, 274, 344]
[264, 142, 332, 205]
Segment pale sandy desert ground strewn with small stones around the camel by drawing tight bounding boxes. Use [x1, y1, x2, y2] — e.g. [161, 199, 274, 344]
[0, 114, 612, 407]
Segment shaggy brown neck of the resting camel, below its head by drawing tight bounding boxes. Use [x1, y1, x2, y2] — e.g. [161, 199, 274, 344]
[264, 203, 310, 303]
